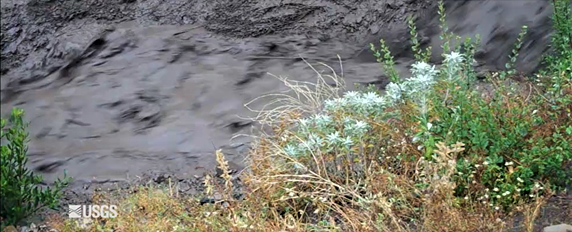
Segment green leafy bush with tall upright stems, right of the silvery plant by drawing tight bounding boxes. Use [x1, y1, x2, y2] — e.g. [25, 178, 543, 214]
[421, 1, 572, 209]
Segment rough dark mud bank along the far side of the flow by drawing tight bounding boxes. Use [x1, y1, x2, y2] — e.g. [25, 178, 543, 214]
[2, 0, 431, 78]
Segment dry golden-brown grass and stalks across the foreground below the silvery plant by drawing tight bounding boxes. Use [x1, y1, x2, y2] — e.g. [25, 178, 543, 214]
[47, 60, 560, 232]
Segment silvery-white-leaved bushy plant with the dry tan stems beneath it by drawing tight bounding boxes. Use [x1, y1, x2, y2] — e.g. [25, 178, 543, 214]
[244, 49, 498, 231]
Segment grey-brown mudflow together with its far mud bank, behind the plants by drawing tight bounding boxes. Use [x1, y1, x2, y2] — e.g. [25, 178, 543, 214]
[1, 0, 551, 185]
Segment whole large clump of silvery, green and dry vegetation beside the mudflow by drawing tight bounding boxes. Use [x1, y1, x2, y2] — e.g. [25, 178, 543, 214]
[49, 1, 572, 231]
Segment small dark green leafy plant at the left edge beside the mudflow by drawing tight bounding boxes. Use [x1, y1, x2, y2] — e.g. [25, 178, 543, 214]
[0, 108, 69, 226]
